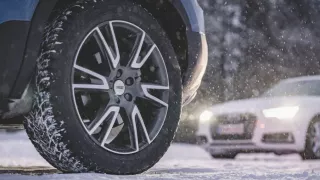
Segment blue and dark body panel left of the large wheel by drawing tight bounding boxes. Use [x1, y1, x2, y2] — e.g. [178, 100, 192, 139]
[0, 0, 38, 102]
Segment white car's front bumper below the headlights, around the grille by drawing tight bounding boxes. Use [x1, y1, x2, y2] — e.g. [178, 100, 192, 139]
[196, 114, 309, 154]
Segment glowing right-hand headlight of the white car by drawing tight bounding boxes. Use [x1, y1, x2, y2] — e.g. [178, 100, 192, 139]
[263, 106, 299, 119]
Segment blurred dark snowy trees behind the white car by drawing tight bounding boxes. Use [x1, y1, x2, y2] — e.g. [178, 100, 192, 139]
[176, 0, 320, 142]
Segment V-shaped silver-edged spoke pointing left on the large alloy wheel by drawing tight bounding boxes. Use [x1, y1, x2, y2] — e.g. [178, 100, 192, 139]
[72, 65, 109, 90]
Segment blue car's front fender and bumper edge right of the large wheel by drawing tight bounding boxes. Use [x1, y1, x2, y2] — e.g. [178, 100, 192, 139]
[173, 0, 208, 102]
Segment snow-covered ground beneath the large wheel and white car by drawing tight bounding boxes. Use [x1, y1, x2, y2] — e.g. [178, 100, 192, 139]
[0, 132, 320, 180]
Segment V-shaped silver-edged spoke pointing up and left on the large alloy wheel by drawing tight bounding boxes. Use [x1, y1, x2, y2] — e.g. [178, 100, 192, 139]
[94, 22, 120, 68]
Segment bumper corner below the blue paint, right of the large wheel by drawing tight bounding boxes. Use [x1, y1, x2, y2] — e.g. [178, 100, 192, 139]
[182, 31, 208, 105]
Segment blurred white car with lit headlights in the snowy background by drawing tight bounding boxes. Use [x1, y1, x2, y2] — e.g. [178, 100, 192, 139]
[196, 76, 320, 159]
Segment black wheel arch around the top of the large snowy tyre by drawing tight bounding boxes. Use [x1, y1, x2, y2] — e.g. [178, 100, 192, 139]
[10, 0, 191, 99]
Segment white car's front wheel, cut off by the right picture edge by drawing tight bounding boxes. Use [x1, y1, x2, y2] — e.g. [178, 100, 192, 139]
[300, 118, 320, 160]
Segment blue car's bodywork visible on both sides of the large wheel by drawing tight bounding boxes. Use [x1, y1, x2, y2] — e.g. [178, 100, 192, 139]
[0, 0, 207, 114]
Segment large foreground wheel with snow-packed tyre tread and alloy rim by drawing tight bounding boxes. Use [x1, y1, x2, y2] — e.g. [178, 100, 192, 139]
[25, 0, 182, 174]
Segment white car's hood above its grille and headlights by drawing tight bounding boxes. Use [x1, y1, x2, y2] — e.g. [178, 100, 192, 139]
[211, 96, 320, 114]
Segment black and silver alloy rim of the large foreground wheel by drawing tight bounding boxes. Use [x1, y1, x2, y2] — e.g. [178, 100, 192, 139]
[72, 20, 169, 154]
